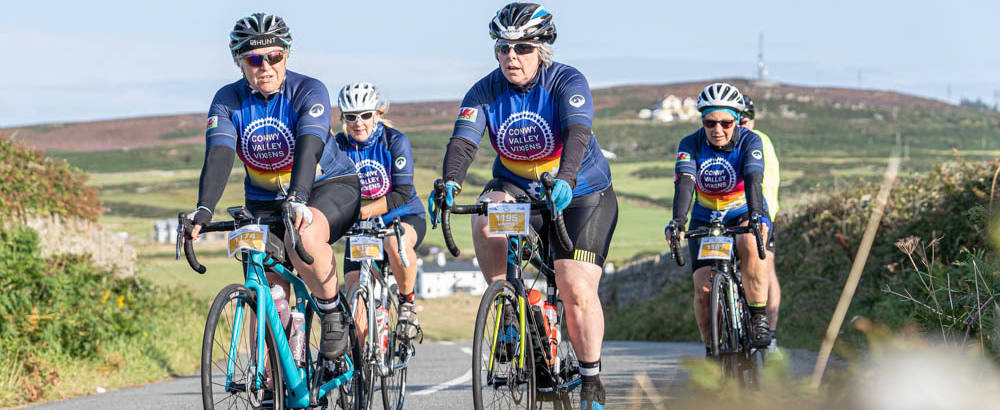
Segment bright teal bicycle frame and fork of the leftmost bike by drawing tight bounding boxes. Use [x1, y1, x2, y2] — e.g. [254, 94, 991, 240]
[226, 249, 354, 408]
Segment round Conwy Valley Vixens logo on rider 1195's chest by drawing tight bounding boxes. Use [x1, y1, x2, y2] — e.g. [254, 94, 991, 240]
[496, 111, 556, 161]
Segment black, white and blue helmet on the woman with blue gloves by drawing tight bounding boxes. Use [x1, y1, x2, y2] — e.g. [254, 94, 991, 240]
[490, 3, 556, 44]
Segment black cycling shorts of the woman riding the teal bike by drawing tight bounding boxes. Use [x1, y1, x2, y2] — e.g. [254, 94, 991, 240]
[246, 175, 361, 244]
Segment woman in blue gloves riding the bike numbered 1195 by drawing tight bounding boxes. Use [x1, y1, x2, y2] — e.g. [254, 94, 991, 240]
[434, 3, 618, 409]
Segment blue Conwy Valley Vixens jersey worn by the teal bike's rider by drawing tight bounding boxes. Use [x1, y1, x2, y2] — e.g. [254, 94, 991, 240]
[205, 71, 354, 201]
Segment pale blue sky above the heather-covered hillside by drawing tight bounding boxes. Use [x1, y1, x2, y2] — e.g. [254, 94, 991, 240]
[0, 0, 1000, 127]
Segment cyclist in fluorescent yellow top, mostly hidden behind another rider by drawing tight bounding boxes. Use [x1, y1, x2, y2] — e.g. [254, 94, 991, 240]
[740, 94, 781, 353]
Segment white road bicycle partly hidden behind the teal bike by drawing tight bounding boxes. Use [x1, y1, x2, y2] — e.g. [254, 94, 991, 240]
[341, 218, 422, 409]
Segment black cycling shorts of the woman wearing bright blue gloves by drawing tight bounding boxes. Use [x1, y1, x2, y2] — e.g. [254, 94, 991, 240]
[480, 178, 618, 268]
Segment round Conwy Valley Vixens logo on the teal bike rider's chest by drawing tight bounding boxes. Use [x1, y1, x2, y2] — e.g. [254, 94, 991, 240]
[240, 117, 295, 171]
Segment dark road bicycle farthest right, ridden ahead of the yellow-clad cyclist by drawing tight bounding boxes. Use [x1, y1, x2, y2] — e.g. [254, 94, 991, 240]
[670, 218, 767, 389]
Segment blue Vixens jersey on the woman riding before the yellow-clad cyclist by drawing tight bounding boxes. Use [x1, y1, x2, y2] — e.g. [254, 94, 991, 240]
[674, 127, 767, 222]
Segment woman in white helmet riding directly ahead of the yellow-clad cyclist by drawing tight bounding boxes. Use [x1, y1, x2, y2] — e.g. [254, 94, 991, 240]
[666, 83, 774, 355]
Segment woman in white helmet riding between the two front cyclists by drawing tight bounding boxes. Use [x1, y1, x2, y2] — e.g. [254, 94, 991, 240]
[335, 82, 427, 340]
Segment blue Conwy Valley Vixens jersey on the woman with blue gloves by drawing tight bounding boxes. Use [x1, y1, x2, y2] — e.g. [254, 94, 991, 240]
[452, 63, 611, 197]
